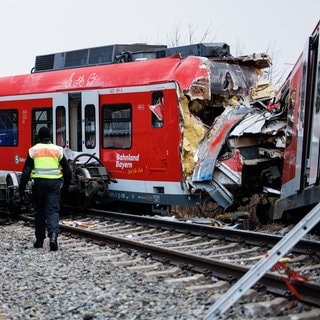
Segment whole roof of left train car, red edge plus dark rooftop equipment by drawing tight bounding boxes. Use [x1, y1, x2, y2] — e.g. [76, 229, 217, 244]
[0, 39, 271, 99]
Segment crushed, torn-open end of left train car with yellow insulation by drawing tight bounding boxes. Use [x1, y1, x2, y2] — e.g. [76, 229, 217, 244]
[180, 54, 286, 219]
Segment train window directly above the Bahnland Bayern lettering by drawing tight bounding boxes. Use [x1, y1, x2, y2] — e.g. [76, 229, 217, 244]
[103, 104, 132, 149]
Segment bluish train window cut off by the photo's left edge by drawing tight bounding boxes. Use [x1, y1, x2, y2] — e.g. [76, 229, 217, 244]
[0, 110, 18, 146]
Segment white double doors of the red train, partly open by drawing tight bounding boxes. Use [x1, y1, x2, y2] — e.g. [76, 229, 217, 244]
[53, 92, 99, 157]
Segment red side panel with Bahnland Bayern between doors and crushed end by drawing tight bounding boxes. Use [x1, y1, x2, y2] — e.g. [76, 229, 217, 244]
[100, 83, 198, 204]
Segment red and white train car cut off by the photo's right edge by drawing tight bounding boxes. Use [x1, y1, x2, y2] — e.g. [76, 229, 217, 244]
[271, 23, 320, 219]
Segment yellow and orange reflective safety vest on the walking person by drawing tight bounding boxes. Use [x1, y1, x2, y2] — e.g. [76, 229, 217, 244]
[29, 143, 63, 179]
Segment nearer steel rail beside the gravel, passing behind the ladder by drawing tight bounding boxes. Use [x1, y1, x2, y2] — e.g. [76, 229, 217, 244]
[21, 215, 320, 307]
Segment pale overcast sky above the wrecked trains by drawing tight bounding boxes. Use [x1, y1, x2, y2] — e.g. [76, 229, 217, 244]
[0, 0, 320, 86]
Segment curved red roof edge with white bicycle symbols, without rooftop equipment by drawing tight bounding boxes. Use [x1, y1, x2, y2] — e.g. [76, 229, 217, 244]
[0, 55, 209, 97]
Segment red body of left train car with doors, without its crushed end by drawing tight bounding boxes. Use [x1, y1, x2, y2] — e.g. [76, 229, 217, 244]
[0, 56, 218, 210]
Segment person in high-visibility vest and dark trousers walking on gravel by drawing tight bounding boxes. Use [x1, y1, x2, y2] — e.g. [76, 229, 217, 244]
[19, 127, 72, 251]
